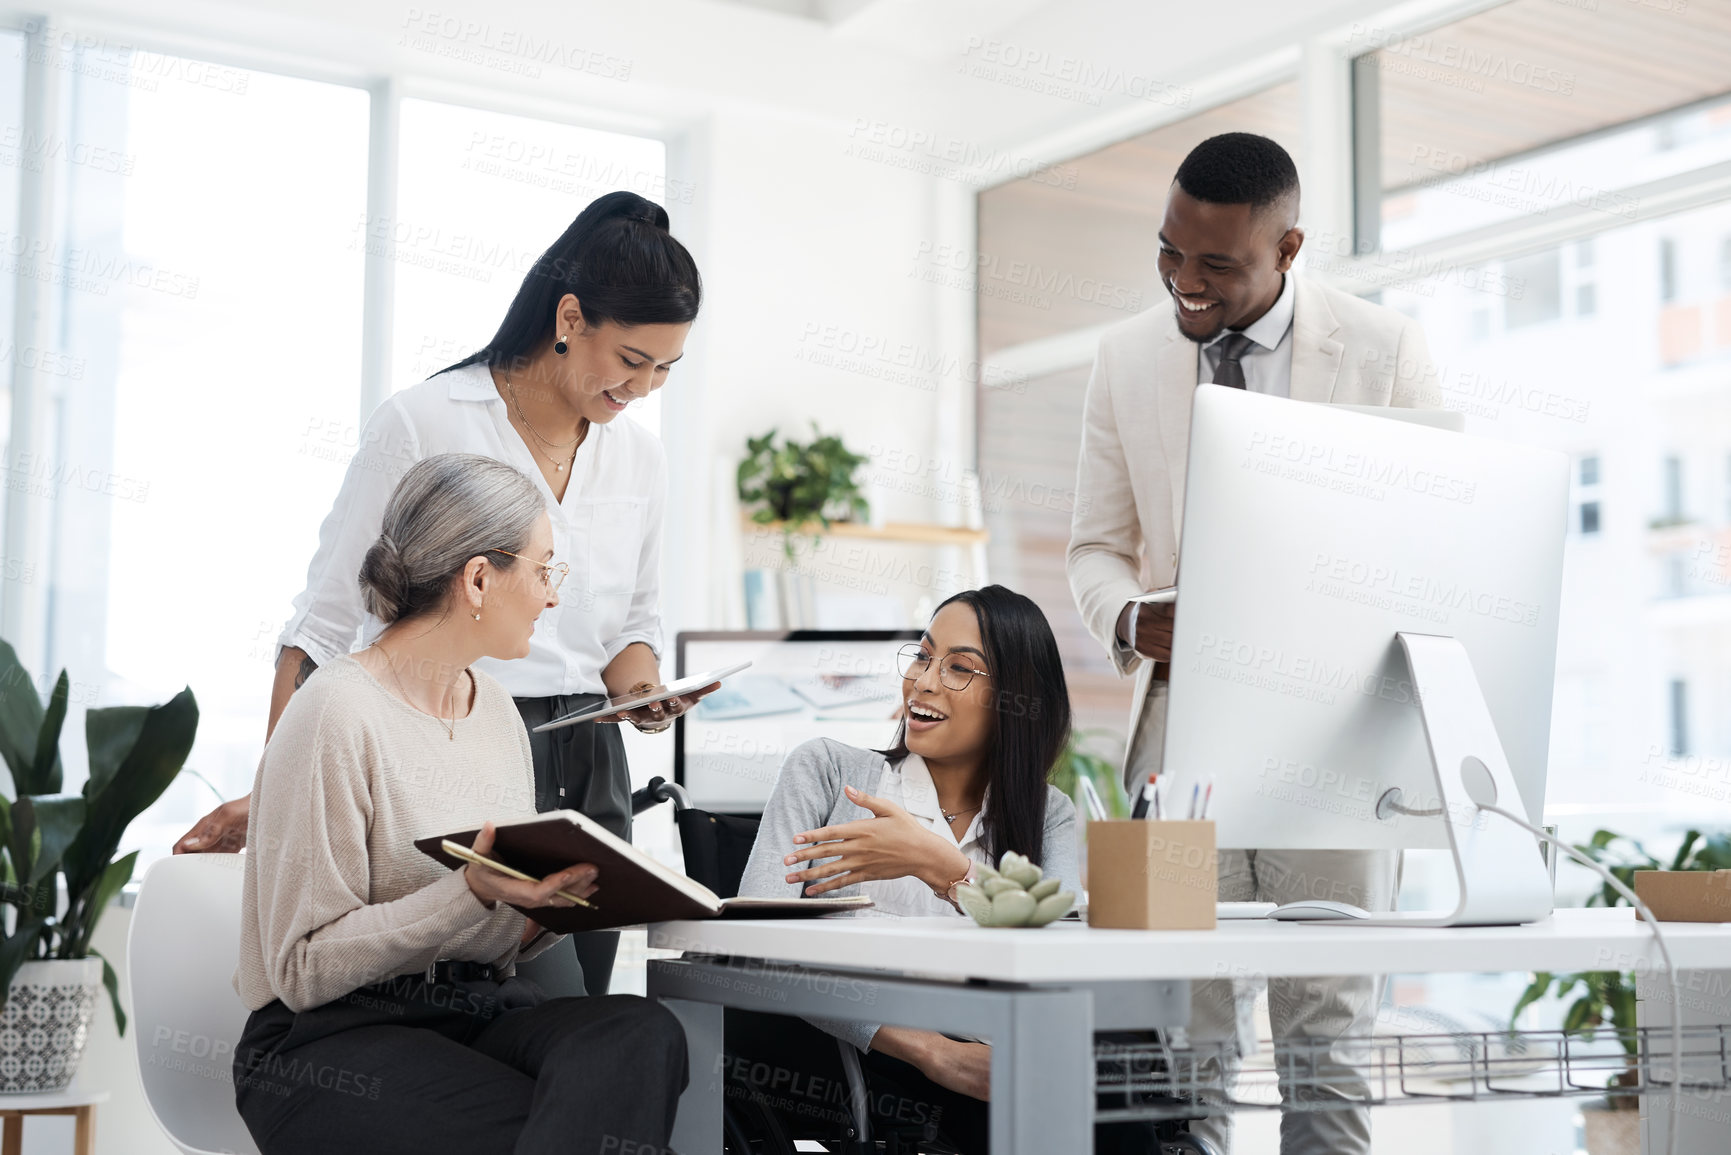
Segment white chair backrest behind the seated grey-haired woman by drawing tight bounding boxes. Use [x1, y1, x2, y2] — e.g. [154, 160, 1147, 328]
[126, 854, 258, 1155]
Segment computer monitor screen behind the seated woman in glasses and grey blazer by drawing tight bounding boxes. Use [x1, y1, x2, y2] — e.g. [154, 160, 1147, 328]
[673, 630, 919, 814]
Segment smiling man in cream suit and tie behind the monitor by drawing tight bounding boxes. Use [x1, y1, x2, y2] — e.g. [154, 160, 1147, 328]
[1068, 133, 1440, 1155]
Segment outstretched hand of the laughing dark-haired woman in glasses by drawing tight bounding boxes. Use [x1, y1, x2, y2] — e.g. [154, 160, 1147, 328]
[782, 786, 969, 895]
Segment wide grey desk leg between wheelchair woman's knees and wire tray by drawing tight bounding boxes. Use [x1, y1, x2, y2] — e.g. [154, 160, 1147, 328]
[992, 990, 1094, 1155]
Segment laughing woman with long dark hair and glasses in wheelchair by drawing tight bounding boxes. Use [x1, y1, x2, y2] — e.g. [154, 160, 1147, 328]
[727, 585, 1082, 1155]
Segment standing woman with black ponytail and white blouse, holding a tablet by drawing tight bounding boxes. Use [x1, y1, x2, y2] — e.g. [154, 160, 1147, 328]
[175, 192, 703, 994]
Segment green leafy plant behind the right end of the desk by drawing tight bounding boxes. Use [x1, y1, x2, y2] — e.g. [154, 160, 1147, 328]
[1509, 829, 1731, 1155]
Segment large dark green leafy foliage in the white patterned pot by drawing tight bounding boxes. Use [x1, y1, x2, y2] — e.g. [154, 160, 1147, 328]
[0, 642, 199, 1034]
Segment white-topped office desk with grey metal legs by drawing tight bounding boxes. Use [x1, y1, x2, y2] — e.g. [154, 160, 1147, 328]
[649, 907, 1731, 1155]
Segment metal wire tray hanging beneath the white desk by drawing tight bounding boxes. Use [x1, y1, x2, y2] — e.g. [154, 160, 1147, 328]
[1094, 1025, 1731, 1122]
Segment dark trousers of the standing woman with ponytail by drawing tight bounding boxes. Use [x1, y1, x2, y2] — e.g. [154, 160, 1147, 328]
[516, 694, 632, 996]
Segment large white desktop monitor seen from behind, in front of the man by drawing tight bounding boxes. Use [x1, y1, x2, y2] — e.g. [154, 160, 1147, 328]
[1163, 386, 1568, 865]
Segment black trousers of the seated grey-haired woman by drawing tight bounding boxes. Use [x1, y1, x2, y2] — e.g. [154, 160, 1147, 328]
[234, 975, 685, 1155]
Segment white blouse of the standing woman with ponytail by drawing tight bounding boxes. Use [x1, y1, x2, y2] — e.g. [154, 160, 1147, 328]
[277, 365, 666, 698]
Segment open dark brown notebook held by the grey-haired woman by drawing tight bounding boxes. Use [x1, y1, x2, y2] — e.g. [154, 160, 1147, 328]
[415, 810, 871, 935]
